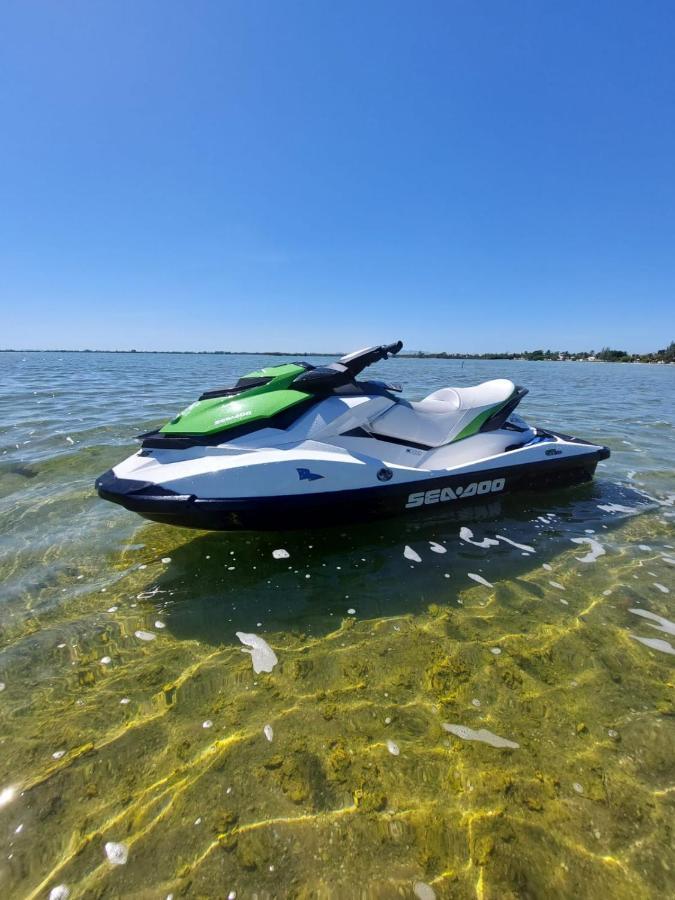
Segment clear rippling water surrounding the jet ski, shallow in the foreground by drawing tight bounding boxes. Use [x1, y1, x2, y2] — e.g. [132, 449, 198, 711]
[0, 353, 675, 898]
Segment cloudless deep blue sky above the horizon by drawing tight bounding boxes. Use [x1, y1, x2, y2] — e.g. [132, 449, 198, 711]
[0, 0, 675, 352]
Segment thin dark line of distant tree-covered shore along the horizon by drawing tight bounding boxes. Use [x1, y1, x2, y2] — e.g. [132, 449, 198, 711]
[0, 342, 675, 365]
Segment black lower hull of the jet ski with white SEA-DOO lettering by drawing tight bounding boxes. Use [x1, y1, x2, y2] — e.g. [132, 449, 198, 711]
[96, 448, 609, 531]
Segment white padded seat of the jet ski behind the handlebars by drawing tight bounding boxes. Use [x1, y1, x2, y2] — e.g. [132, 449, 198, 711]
[370, 378, 517, 447]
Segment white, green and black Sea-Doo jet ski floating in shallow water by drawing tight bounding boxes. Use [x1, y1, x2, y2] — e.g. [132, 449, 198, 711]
[96, 341, 609, 531]
